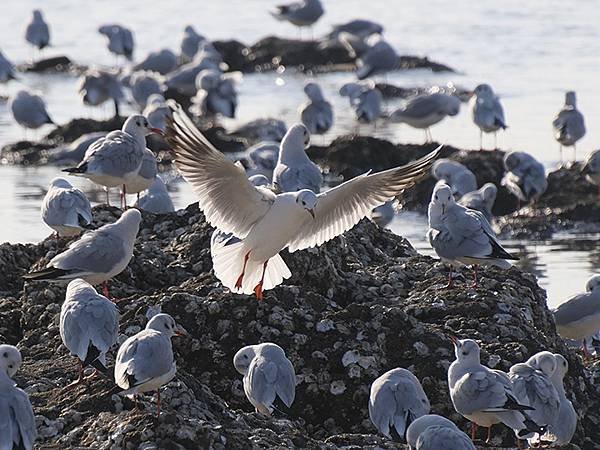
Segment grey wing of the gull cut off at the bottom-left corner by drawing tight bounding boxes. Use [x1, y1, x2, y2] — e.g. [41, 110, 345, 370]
[0, 386, 37, 450]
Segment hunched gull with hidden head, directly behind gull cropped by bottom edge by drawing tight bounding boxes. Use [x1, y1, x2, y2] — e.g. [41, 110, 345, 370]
[369, 368, 431, 439]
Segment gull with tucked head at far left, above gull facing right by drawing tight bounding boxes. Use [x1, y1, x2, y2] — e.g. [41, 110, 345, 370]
[42, 178, 92, 238]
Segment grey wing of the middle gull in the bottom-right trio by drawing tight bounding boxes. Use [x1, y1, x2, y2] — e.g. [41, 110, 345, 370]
[509, 364, 560, 425]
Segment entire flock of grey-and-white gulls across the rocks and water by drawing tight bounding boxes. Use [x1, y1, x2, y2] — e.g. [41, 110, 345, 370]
[0, 0, 600, 450]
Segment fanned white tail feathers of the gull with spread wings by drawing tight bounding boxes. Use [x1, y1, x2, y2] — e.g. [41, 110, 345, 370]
[211, 241, 292, 295]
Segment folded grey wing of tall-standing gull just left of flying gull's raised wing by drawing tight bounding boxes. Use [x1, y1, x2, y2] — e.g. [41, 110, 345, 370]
[86, 131, 144, 177]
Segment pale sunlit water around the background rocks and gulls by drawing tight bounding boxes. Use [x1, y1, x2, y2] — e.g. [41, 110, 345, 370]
[0, 0, 600, 305]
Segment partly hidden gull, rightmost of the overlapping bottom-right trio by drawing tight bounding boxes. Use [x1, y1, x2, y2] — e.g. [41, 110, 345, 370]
[530, 353, 577, 446]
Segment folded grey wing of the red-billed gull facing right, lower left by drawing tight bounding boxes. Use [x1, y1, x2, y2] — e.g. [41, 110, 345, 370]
[115, 330, 173, 389]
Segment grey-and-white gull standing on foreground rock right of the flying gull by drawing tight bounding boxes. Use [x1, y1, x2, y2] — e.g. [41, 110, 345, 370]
[427, 184, 519, 287]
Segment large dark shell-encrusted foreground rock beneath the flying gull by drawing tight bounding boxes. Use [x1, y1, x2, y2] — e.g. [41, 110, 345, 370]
[0, 205, 600, 449]
